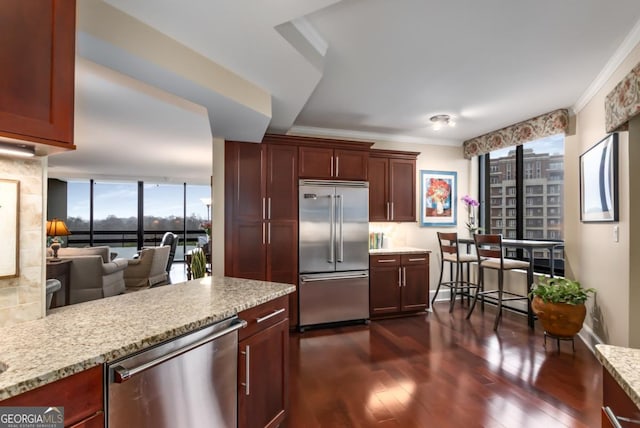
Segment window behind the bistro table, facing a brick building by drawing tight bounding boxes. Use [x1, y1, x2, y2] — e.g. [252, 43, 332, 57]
[480, 134, 564, 272]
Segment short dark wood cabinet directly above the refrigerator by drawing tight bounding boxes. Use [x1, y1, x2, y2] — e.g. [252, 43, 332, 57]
[299, 146, 369, 180]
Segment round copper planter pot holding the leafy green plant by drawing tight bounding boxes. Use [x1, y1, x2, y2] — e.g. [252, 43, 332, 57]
[531, 296, 587, 337]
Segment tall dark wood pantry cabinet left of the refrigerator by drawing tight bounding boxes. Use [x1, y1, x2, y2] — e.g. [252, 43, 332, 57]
[225, 141, 298, 325]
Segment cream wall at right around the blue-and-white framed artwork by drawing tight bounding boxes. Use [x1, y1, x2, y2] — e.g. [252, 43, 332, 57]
[564, 41, 640, 347]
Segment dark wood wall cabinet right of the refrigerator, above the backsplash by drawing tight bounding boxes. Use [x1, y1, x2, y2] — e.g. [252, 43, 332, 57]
[368, 150, 419, 222]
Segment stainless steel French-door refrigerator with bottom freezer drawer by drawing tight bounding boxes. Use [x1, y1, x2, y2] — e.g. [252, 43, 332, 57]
[298, 180, 369, 331]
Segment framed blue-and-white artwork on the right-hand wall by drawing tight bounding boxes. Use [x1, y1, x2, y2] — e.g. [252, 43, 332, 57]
[580, 133, 618, 223]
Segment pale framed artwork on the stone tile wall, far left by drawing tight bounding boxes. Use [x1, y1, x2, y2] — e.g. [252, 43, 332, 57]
[0, 178, 20, 278]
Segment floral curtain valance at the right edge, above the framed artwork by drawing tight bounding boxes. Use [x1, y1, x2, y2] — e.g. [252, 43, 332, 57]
[604, 64, 640, 132]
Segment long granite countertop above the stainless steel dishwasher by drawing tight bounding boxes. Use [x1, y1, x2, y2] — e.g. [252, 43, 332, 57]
[0, 277, 295, 400]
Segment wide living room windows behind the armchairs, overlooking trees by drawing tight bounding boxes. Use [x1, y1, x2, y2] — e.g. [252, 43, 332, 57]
[67, 180, 211, 261]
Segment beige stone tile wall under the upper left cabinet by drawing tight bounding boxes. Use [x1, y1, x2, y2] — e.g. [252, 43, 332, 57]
[0, 157, 47, 326]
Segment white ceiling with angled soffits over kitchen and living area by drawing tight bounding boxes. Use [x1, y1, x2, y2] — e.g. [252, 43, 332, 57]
[49, 0, 640, 183]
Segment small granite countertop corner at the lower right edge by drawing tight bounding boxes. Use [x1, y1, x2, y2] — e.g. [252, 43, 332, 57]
[596, 345, 640, 408]
